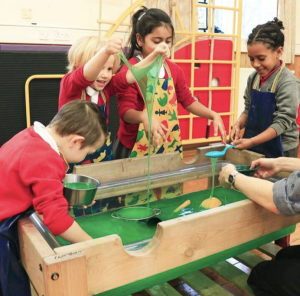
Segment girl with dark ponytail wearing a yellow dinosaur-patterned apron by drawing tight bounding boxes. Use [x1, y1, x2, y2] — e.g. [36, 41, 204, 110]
[113, 7, 226, 159]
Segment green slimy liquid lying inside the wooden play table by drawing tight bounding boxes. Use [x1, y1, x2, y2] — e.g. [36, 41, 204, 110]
[59, 186, 247, 245]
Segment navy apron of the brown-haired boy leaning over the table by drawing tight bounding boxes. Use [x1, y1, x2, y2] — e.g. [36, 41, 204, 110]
[0, 214, 31, 296]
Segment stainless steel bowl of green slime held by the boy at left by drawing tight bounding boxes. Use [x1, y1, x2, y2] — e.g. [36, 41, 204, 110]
[63, 174, 100, 207]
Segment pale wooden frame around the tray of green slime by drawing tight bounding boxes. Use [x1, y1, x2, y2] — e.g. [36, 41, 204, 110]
[19, 148, 300, 296]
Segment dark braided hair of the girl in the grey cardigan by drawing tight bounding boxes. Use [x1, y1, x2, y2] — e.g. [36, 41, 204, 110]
[247, 17, 284, 50]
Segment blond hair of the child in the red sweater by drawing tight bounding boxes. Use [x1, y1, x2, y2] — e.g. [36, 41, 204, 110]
[67, 36, 120, 73]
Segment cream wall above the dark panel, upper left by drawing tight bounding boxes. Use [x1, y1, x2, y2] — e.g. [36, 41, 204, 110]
[0, 0, 131, 45]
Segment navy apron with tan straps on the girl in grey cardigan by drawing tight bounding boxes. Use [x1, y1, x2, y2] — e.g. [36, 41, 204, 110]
[243, 63, 284, 158]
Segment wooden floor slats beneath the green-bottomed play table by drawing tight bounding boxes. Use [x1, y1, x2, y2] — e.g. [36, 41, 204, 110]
[129, 243, 281, 296]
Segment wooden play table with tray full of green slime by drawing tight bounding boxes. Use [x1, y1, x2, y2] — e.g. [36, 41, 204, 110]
[19, 148, 299, 296]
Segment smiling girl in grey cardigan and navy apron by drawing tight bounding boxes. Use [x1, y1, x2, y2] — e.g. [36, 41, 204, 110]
[231, 18, 300, 247]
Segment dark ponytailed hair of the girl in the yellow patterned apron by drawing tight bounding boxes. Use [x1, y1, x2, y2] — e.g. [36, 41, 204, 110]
[127, 6, 174, 59]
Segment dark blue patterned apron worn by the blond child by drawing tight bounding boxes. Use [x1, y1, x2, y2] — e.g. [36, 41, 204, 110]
[67, 90, 113, 173]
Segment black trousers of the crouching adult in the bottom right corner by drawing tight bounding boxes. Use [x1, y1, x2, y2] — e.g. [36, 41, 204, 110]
[248, 245, 300, 296]
